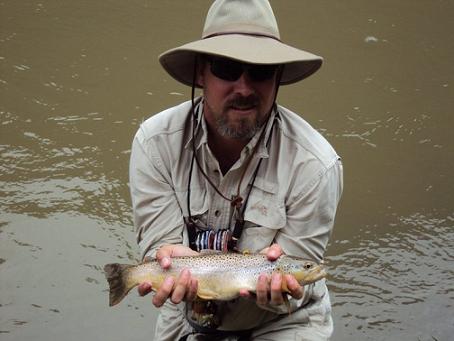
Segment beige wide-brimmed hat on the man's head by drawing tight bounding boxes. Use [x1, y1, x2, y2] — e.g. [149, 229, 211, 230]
[159, 0, 323, 87]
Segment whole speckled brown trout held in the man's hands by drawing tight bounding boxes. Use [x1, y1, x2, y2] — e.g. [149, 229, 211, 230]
[104, 253, 326, 306]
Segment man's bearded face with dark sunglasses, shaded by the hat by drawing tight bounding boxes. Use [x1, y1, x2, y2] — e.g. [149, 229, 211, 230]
[198, 58, 277, 140]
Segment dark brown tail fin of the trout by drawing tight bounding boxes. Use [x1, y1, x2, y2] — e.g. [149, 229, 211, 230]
[104, 263, 135, 307]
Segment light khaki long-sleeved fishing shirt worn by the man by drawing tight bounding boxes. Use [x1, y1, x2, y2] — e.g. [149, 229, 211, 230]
[130, 97, 343, 340]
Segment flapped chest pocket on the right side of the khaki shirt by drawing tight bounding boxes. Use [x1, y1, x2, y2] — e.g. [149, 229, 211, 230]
[238, 178, 287, 252]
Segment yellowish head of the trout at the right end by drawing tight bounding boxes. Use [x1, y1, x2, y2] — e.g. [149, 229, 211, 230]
[281, 257, 327, 285]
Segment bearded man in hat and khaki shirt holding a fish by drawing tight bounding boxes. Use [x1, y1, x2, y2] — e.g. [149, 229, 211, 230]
[130, 0, 342, 340]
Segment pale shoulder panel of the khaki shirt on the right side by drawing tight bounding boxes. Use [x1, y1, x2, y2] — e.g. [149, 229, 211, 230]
[278, 106, 339, 168]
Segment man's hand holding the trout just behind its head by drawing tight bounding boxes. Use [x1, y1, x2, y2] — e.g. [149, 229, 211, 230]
[240, 244, 303, 305]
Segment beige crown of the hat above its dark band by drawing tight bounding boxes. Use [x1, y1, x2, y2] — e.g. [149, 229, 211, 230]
[202, 0, 280, 40]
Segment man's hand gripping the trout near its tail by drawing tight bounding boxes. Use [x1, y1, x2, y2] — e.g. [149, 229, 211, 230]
[138, 245, 198, 308]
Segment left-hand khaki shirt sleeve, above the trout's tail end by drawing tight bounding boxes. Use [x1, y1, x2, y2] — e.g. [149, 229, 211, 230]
[129, 129, 183, 259]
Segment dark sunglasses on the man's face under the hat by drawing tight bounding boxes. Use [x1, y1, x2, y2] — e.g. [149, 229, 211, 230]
[208, 57, 278, 82]
